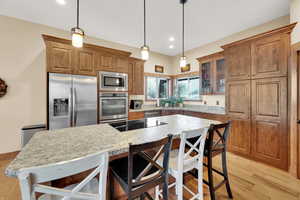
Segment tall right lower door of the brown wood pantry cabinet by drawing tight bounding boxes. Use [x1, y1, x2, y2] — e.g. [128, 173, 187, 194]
[252, 77, 288, 170]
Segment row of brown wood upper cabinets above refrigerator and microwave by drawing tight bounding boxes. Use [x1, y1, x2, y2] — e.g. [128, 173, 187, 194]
[43, 35, 131, 76]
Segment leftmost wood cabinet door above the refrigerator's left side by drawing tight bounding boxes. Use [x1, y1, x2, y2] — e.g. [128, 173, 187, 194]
[47, 41, 75, 74]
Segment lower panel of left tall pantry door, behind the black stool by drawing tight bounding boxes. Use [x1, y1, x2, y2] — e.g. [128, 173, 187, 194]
[228, 119, 251, 158]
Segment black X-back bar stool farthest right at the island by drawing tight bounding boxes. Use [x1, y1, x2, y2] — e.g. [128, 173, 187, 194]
[203, 121, 233, 200]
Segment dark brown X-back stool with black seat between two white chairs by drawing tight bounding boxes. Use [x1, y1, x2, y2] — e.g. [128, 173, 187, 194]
[110, 135, 172, 200]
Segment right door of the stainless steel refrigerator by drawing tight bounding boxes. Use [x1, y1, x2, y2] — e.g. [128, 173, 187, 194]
[73, 75, 97, 126]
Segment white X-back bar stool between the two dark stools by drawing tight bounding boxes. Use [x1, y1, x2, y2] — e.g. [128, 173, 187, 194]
[155, 129, 207, 200]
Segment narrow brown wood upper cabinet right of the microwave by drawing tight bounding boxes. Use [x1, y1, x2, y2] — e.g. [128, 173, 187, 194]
[128, 58, 145, 95]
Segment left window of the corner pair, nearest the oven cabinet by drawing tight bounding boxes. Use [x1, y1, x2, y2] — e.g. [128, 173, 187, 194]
[146, 76, 170, 100]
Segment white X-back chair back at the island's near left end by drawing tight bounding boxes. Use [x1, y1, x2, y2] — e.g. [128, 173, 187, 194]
[18, 152, 108, 200]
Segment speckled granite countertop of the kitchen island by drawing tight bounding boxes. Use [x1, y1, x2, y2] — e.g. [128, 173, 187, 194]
[5, 115, 220, 177]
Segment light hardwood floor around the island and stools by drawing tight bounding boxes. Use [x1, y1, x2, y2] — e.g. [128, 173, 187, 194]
[0, 154, 300, 200]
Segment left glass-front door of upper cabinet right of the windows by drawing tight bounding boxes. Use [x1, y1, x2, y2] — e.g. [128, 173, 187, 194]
[200, 62, 212, 95]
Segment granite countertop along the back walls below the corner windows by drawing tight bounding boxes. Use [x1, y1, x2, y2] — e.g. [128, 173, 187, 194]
[129, 106, 226, 115]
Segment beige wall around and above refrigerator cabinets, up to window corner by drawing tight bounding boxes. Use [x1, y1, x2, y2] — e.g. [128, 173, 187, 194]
[0, 16, 171, 154]
